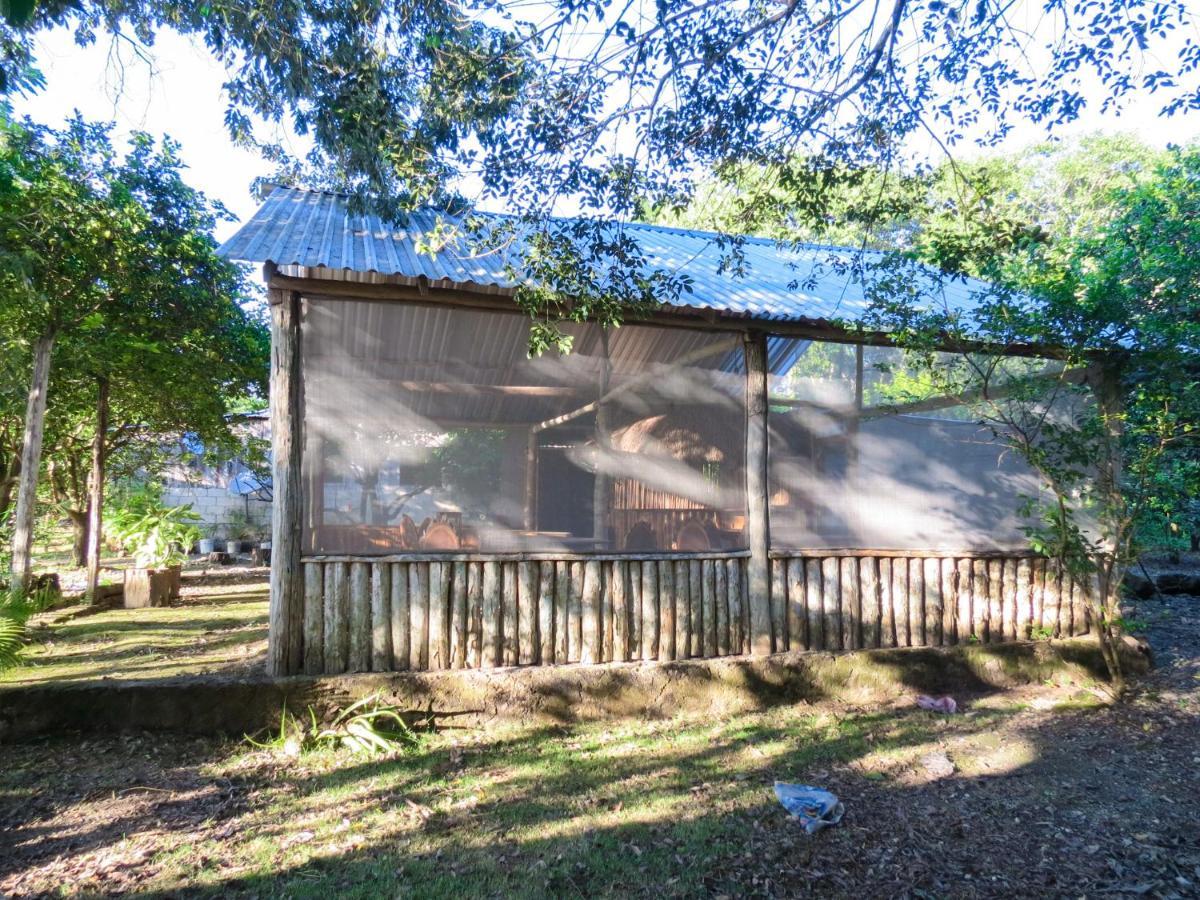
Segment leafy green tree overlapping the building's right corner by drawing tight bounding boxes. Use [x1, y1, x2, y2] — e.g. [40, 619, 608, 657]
[868, 150, 1200, 695]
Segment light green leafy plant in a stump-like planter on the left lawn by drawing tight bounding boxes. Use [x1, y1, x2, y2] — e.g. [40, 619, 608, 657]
[113, 497, 200, 607]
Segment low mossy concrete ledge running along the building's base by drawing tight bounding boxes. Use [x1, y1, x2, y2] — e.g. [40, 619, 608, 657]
[0, 638, 1150, 740]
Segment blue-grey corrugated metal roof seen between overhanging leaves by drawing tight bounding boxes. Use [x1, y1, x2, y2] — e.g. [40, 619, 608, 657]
[221, 187, 985, 322]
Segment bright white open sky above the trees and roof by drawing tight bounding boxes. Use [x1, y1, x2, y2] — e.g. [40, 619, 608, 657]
[14, 17, 1200, 240]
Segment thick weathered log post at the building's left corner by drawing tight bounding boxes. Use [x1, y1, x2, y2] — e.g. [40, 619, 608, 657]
[266, 290, 304, 676]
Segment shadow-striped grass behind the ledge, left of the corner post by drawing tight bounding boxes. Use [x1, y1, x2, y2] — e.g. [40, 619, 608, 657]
[0, 584, 268, 684]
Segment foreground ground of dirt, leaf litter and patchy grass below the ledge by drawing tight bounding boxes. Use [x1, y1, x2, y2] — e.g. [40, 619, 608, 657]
[0, 580, 1200, 898]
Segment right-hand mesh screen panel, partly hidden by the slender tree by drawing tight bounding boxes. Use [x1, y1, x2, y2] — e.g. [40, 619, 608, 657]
[768, 338, 1039, 551]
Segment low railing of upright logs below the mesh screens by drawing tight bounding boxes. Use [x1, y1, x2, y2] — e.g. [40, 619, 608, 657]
[292, 551, 1087, 674]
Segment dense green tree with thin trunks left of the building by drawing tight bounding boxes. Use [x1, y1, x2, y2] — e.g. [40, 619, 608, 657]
[0, 111, 268, 589]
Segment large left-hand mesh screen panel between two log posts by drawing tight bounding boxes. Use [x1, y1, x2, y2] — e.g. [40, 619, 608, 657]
[301, 298, 745, 556]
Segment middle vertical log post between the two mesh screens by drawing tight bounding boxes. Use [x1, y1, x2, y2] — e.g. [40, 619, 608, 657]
[744, 332, 774, 655]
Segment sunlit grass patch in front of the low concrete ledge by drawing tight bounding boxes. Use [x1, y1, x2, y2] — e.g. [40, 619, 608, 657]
[0, 707, 1041, 898]
